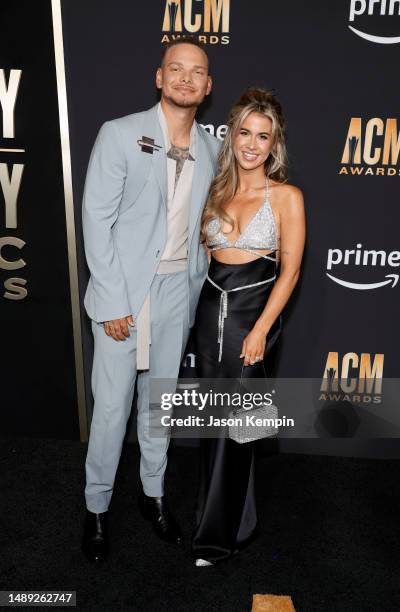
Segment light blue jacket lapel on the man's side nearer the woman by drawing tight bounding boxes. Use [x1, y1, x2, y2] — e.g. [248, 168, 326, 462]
[189, 123, 214, 244]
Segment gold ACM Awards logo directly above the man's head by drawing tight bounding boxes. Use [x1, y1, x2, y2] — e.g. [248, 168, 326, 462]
[161, 0, 230, 45]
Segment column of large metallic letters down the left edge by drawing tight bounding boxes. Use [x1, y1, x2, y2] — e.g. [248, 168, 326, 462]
[0, 68, 28, 300]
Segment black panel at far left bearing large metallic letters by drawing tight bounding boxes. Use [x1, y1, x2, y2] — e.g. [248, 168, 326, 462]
[0, 0, 79, 439]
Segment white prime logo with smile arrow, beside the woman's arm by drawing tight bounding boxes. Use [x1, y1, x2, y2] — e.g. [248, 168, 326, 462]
[326, 242, 400, 291]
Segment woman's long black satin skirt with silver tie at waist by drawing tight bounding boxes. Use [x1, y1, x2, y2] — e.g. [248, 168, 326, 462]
[192, 257, 280, 563]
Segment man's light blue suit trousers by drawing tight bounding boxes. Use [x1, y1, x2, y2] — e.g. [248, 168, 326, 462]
[85, 270, 189, 513]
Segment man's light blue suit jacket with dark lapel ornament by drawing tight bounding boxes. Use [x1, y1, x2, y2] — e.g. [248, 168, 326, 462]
[83, 105, 220, 326]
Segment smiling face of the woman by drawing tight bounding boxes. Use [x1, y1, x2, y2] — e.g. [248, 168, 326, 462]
[233, 112, 273, 170]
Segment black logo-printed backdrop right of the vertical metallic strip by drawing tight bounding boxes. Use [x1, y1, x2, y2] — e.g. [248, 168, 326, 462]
[62, 0, 400, 450]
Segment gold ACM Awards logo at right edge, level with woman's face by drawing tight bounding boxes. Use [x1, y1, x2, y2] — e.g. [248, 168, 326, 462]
[339, 117, 400, 176]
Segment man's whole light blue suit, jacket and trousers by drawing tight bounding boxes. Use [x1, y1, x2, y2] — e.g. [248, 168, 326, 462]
[83, 106, 220, 513]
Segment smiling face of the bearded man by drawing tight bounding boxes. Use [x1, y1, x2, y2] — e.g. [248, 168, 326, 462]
[156, 43, 212, 108]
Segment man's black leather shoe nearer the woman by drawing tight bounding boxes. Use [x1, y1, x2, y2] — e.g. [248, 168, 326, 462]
[138, 492, 182, 544]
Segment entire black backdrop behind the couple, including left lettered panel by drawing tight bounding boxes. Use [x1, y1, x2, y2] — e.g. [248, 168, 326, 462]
[0, 0, 400, 455]
